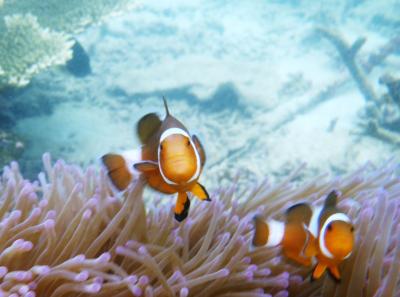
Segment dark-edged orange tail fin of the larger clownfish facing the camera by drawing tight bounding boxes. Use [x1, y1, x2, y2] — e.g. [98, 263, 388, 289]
[101, 154, 133, 191]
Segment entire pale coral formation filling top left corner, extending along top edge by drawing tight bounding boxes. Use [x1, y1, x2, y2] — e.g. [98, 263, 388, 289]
[0, 0, 140, 89]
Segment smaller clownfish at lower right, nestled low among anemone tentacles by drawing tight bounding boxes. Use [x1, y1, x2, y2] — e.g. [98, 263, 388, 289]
[253, 191, 355, 281]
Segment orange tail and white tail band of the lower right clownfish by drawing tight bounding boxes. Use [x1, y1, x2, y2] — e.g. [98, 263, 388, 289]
[253, 216, 285, 247]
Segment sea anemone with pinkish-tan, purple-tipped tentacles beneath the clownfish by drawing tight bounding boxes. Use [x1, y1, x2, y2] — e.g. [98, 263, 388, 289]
[0, 154, 400, 297]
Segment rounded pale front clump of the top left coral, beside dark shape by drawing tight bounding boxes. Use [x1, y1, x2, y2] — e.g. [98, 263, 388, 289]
[0, 14, 72, 88]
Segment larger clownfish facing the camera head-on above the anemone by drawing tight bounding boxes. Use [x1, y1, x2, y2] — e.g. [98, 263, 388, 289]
[102, 98, 211, 222]
